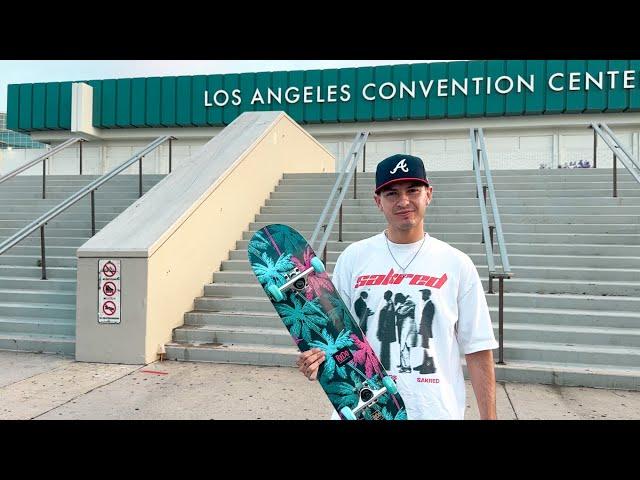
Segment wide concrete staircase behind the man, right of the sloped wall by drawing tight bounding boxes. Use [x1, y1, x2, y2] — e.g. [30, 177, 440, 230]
[167, 169, 640, 389]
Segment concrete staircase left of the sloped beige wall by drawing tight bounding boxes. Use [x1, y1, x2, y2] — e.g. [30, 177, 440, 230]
[0, 175, 164, 355]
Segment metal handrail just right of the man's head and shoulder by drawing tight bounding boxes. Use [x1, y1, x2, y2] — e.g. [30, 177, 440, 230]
[469, 128, 513, 365]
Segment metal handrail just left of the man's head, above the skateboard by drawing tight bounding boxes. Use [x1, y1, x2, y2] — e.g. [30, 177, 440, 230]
[309, 132, 369, 264]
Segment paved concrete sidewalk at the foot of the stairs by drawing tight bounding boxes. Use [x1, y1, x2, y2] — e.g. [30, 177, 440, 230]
[0, 351, 640, 420]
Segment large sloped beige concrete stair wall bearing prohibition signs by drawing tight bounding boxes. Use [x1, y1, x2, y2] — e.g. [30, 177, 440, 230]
[76, 112, 335, 364]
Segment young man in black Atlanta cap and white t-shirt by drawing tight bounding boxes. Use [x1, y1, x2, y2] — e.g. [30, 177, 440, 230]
[298, 154, 498, 420]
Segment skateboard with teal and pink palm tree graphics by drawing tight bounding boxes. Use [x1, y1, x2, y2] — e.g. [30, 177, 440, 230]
[248, 224, 407, 420]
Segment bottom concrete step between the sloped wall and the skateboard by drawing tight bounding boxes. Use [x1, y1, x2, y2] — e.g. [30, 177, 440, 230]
[165, 342, 299, 367]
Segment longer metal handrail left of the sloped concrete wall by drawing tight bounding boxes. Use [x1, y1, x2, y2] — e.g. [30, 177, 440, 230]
[0, 136, 174, 280]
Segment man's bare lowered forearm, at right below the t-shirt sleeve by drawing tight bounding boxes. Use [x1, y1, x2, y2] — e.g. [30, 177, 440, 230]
[465, 350, 497, 420]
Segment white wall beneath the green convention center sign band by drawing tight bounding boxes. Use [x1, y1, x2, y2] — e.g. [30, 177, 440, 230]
[33, 112, 640, 173]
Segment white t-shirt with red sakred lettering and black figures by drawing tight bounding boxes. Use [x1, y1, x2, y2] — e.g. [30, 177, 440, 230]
[332, 233, 498, 420]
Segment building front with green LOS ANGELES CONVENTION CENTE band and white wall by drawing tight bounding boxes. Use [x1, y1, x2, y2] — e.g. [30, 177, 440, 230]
[8, 60, 640, 174]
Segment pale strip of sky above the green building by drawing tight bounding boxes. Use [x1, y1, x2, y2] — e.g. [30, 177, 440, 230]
[0, 60, 442, 112]
